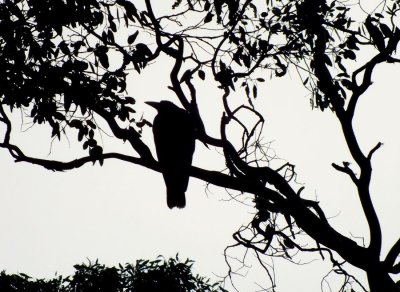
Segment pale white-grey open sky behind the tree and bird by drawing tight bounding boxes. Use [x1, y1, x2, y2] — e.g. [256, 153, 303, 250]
[0, 0, 400, 291]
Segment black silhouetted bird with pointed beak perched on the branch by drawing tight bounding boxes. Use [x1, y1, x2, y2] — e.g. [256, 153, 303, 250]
[146, 100, 196, 209]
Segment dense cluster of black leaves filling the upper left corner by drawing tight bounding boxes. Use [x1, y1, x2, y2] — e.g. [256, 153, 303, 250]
[0, 0, 149, 160]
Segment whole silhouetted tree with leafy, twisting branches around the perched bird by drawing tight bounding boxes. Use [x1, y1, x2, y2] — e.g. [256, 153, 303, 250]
[0, 0, 400, 291]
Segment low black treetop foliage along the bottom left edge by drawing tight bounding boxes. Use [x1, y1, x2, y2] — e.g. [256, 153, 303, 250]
[0, 257, 226, 292]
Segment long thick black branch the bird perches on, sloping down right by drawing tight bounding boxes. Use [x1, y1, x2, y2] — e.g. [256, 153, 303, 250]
[0, 130, 367, 267]
